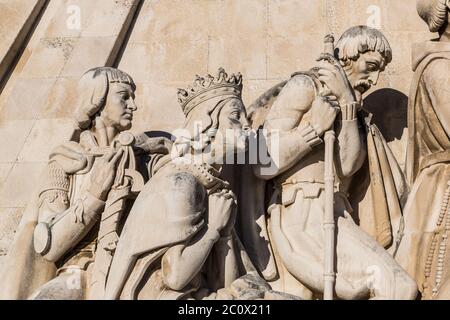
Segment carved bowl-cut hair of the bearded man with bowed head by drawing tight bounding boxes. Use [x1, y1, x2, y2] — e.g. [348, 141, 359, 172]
[335, 26, 392, 63]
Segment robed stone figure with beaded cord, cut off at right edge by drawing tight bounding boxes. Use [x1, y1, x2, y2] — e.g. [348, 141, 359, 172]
[396, 0, 450, 299]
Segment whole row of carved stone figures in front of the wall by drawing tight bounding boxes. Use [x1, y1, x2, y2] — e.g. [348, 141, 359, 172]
[0, 0, 450, 300]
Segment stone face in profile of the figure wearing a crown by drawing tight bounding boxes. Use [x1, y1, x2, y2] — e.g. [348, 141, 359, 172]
[212, 98, 250, 160]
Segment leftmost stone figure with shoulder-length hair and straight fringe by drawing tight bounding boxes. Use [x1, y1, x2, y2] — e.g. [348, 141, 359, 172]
[0, 67, 167, 299]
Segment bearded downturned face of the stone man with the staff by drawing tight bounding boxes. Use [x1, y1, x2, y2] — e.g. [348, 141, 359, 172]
[345, 51, 386, 94]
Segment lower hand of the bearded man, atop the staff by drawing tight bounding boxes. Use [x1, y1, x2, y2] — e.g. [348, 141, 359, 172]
[311, 96, 339, 136]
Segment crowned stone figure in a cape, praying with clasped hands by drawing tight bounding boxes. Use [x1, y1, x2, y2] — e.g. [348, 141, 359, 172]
[105, 69, 294, 299]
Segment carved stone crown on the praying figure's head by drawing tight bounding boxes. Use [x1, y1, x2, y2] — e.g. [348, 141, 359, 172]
[178, 68, 242, 117]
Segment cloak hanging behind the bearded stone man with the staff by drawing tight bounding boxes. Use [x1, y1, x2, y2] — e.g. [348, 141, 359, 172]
[227, 72, 408, 283]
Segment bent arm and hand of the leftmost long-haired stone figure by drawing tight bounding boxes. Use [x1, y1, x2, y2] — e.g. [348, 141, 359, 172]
[34, 151, 122, 262]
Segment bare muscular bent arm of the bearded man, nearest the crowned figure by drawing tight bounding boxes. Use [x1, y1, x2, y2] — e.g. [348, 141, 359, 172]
[254, 75, 322, 180]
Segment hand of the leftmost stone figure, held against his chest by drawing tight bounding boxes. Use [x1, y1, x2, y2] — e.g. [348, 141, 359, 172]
[89, 149, 123, 201]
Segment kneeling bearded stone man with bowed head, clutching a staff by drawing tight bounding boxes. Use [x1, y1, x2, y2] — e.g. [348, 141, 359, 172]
[250, 26, 417, 299]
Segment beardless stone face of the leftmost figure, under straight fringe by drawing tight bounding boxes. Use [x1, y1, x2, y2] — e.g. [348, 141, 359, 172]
[100, 82, 137, 132]
